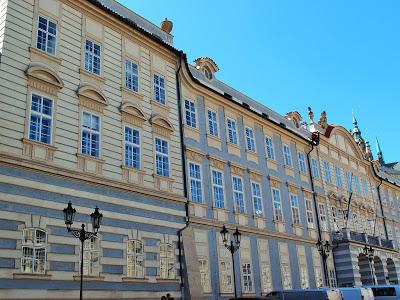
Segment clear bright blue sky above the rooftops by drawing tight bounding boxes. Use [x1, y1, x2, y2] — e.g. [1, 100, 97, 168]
[119, 0, 400, 162]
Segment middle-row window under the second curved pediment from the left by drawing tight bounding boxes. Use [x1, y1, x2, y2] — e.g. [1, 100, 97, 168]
[82, 111, 100, 157]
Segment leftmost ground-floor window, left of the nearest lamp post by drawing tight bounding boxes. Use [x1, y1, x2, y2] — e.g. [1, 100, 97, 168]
[21, 228, 47, 274]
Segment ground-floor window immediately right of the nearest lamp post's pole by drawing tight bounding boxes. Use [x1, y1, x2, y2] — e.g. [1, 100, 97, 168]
[83, 236, 100, 276]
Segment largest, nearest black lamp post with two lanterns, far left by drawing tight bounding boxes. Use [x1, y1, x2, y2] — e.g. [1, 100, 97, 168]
[63, 202, 103, 300]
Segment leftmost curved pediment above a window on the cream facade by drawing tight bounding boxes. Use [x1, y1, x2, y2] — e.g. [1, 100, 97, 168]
[25, 63, 64, 95]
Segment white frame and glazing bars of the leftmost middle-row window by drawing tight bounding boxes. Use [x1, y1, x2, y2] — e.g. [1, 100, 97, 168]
[28, 93, 54, 145]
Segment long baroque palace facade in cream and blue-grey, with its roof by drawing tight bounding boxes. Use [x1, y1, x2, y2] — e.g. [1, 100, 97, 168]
[0, 0, 400, 299]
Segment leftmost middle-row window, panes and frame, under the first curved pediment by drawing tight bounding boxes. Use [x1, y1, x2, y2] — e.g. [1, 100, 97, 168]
[29, 94, 53, 144]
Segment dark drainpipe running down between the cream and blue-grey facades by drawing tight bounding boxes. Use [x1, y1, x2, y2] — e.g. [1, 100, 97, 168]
[175, 51, 189, 300]
